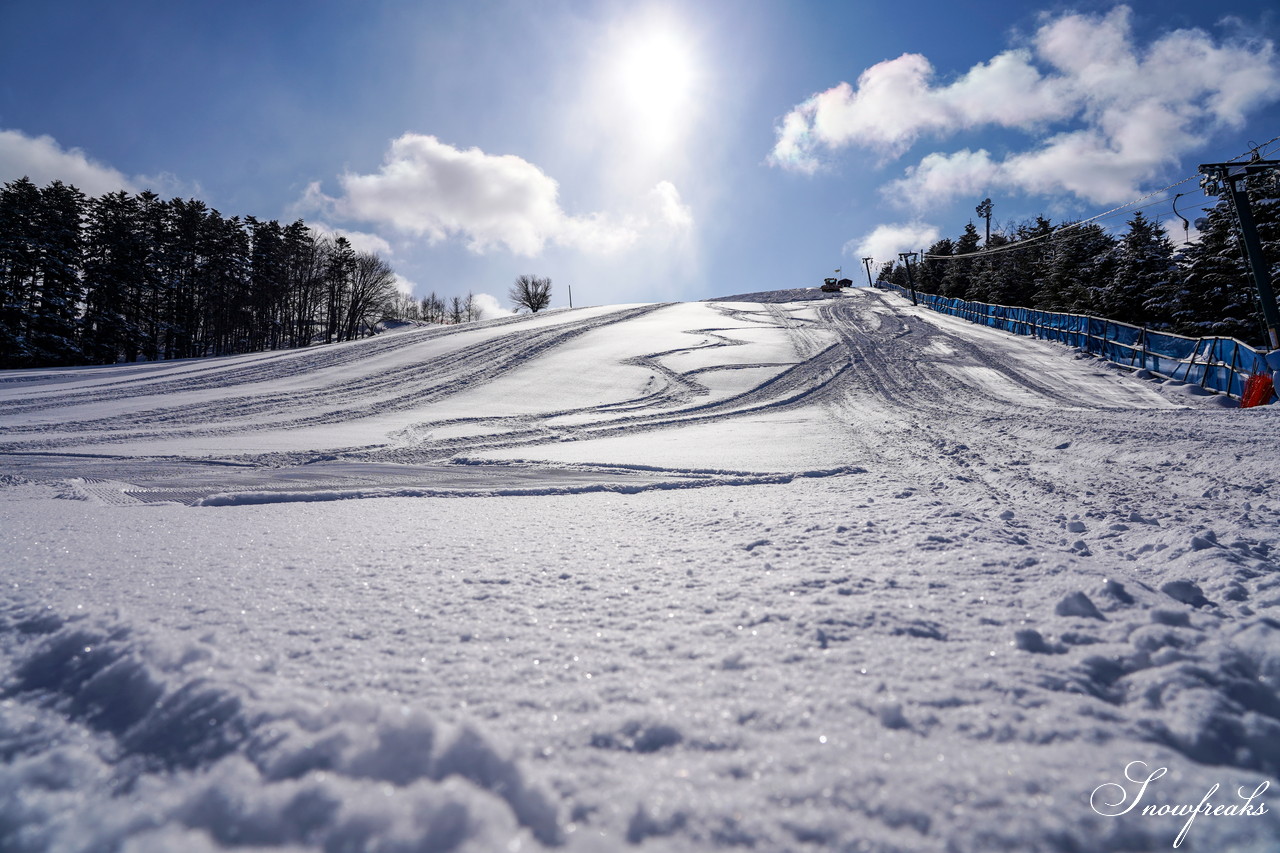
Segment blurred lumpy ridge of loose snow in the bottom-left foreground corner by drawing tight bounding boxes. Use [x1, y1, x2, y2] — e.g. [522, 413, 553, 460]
[0, 603, 564, 852]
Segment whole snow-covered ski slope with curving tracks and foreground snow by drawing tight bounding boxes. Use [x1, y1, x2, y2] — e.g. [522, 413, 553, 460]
[0, 289, 1280, 853]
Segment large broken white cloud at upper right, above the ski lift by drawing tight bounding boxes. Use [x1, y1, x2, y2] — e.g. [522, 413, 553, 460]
[769, 6, 1280, 207]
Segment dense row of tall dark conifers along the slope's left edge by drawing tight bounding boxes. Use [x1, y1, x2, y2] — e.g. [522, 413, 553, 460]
[0, 178, 398, 368]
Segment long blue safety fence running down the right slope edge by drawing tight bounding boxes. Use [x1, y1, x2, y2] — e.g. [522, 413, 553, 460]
[876, 280, 1276, 401]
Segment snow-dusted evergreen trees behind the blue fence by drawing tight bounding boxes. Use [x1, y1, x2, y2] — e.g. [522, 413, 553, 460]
[879, 186, 1280, 345]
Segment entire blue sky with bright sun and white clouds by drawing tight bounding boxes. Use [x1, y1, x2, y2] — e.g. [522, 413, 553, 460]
[0, 0, 1280, 305]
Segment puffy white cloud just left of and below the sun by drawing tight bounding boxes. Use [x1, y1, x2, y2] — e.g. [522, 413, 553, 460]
[318, 133, 692, 256]
